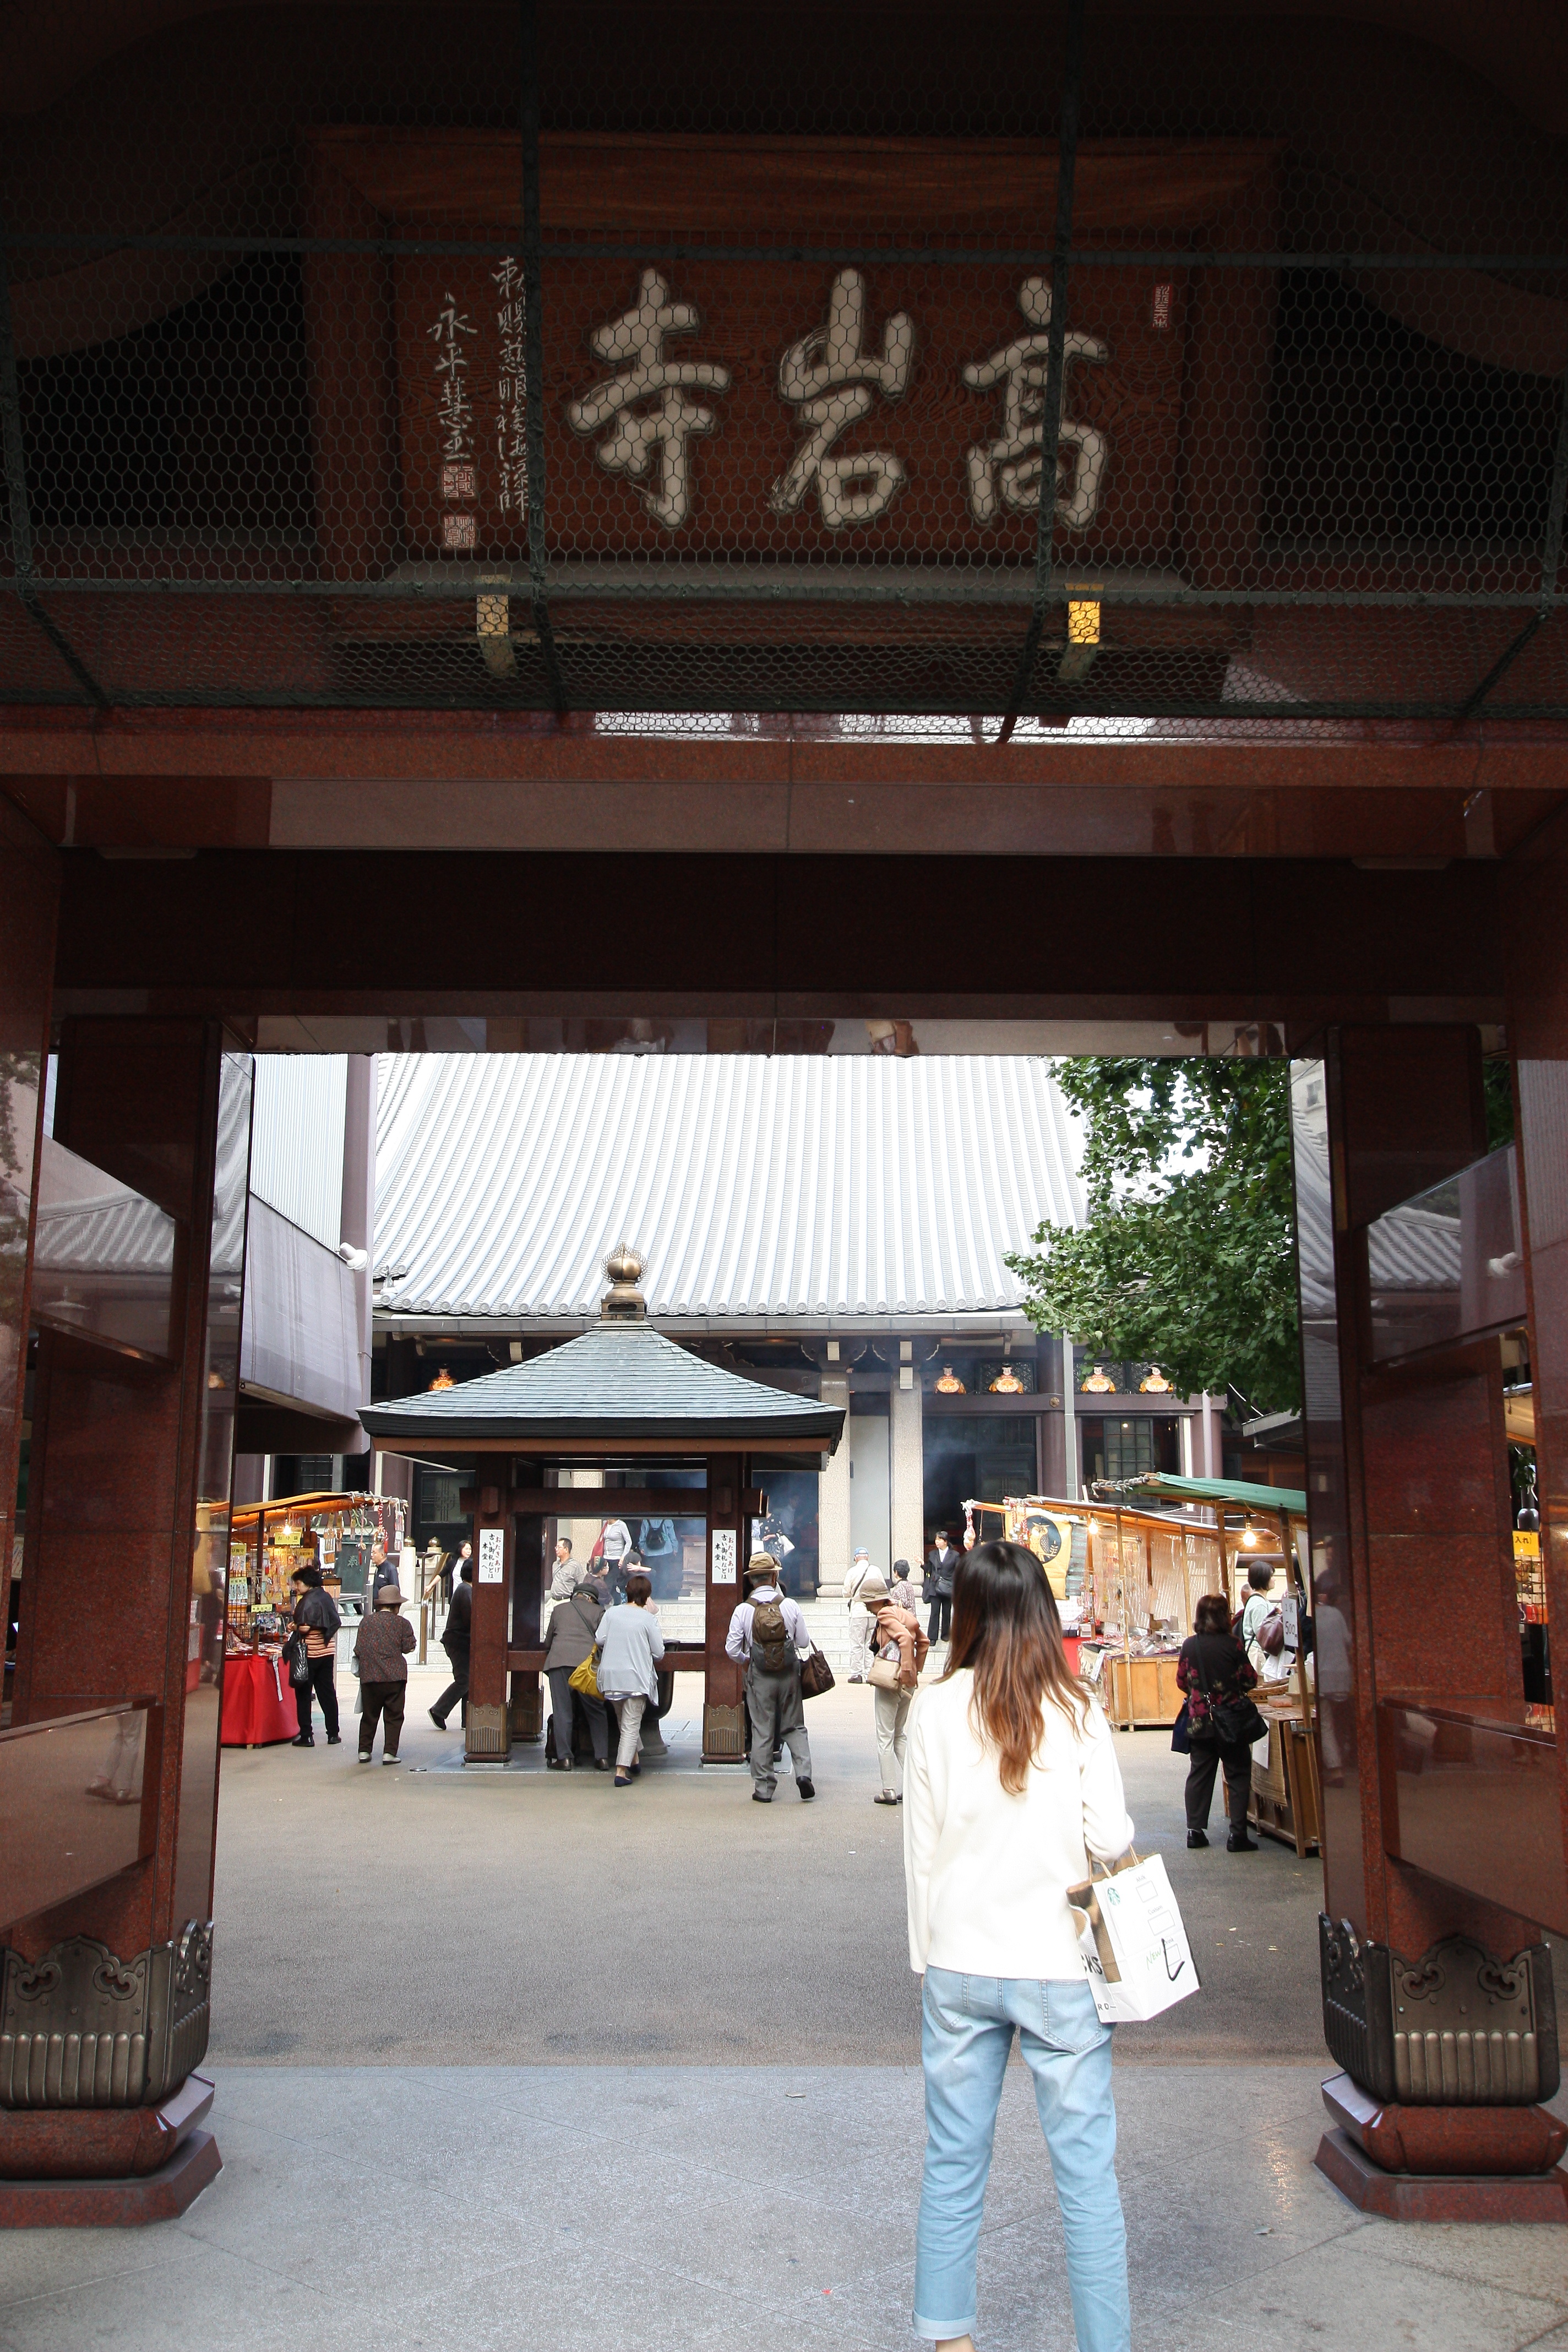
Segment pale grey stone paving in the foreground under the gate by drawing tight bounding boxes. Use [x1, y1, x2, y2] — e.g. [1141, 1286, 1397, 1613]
[0, 2070, 1568, 2352]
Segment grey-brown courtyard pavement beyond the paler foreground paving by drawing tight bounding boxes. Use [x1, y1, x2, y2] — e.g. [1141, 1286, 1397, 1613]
[211, 1672, 1324, 2065]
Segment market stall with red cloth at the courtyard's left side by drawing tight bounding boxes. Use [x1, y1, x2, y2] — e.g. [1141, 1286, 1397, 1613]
[221, 1494, 409, 1747]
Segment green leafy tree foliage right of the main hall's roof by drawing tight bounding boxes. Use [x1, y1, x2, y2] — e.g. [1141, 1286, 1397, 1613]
[1006, 1056, 1300, 1413]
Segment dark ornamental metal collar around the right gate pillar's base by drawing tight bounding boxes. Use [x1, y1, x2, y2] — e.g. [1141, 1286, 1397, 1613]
[1319, 1912, 1561, 2108]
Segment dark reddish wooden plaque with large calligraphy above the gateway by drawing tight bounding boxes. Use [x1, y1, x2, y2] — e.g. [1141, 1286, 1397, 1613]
[306, 129, 1277, 682]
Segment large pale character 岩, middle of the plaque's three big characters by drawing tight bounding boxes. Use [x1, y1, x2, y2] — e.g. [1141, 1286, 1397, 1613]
[769, 270, 914, 531]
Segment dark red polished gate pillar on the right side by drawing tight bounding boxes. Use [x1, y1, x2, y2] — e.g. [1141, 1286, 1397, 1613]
[1293, 1028, 1568, 2218]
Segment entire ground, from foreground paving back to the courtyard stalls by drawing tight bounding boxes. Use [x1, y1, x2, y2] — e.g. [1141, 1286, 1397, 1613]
[0, 1672, 1568, 2352]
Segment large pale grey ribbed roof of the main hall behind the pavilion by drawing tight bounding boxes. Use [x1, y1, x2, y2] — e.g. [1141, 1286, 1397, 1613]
[376, 1054, 1084, 1329]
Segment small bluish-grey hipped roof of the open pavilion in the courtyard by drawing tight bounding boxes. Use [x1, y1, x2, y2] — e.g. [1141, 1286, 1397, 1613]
[360, 1322, 844, 1449]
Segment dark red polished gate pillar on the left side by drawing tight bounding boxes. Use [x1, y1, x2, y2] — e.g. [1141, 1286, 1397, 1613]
[0, 1021, 252, 2220]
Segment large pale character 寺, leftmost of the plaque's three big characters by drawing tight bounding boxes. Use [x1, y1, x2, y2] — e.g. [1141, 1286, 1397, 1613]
[567, 270, 729, 531]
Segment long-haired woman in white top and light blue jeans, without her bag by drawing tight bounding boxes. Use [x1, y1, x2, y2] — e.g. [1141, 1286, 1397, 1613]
[903, 1543, 1133, 2352]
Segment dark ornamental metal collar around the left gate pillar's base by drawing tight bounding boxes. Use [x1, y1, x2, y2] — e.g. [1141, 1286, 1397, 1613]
[0, 1919, 211, 2108]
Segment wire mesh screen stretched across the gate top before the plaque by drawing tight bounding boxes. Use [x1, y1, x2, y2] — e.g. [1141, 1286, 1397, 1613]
[0, 0, 1568, 729]
